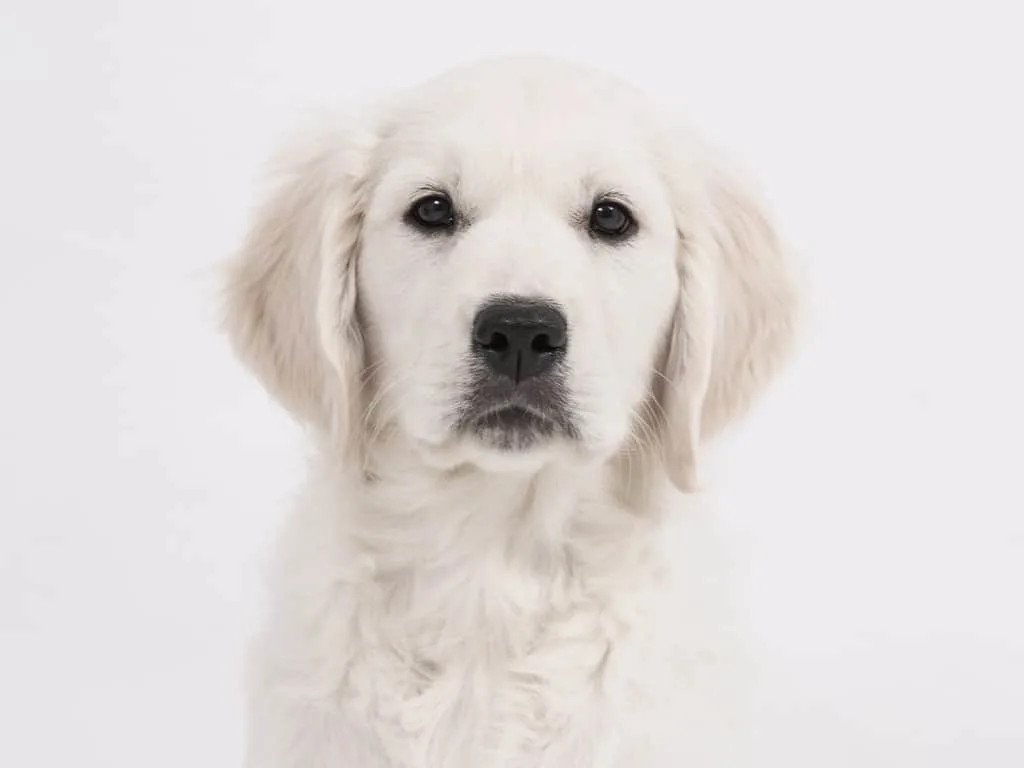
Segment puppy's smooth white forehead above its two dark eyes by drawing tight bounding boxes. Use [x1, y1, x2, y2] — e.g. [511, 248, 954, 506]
[376, 60, 654, 201]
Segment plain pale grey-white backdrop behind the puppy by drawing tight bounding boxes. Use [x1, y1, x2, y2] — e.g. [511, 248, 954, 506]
[0, 0, 1024, 768]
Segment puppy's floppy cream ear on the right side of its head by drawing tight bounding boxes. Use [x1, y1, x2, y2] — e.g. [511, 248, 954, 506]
[662, 150, 798, 490]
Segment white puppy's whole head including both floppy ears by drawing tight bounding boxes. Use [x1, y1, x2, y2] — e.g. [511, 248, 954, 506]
[228, 58, 795, 487]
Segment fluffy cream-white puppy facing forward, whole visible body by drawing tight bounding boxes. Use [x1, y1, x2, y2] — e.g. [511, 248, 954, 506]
[228, 57, 796, 768]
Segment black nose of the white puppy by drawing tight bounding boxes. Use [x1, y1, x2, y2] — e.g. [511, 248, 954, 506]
[473, 297, 567, 384]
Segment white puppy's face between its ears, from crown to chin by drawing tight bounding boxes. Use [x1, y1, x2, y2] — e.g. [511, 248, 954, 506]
[356, 71, 679, 473]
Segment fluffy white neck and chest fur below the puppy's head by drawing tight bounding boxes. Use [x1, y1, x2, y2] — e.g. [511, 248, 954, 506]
[246, 448, 737, 768]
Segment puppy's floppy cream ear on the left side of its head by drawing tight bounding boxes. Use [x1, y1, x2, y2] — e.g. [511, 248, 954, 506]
[226, 118, 373, 452]
